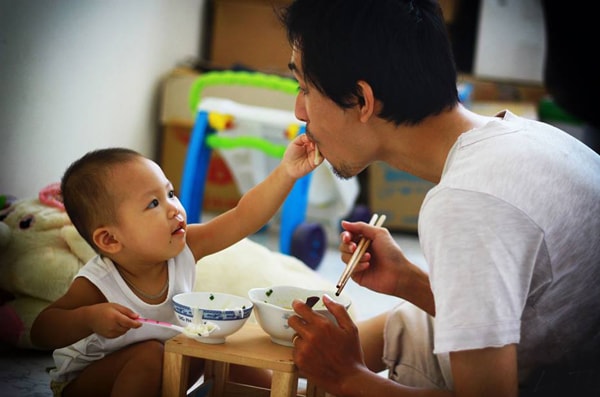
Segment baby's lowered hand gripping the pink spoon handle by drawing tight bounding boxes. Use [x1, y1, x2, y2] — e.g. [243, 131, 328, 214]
[90, 303, 142, 338]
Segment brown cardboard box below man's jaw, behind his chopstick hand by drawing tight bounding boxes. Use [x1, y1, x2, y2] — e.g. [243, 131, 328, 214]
[368, 162, 434, 232]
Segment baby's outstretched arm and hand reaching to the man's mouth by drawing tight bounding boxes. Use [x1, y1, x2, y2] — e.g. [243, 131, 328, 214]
[187, 134, 322, 259]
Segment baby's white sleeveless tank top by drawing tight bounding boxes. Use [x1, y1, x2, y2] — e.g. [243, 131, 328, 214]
[50, 245, 196, 382]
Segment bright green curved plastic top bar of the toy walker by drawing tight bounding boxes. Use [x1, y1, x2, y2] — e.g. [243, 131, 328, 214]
[189, 71, 298, 112]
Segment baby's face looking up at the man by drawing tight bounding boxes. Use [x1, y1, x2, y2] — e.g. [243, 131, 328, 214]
[110, 158, 187, 262]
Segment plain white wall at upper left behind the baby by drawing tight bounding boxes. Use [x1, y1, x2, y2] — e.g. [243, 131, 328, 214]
[0, 0, 205, 198]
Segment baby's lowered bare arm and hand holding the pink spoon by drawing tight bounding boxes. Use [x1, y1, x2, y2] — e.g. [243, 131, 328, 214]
[31, 277, 140, 349]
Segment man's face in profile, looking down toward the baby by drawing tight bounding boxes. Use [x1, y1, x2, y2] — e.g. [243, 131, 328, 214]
[290, 50, 368, 179]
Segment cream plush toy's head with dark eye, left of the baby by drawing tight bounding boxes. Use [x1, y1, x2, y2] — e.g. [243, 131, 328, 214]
[0, 184, 94, 348]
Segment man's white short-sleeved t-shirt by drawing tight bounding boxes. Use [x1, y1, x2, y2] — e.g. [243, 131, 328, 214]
[419, 112, 600, 373]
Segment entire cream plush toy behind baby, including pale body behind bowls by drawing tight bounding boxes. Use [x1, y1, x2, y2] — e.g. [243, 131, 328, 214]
[0, 184, 346, 348]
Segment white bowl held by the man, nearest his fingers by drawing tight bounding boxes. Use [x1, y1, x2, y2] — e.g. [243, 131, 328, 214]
[248, 285, 351, 346]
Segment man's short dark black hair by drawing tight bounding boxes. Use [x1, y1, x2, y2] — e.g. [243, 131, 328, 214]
[280, 0, 458, 124]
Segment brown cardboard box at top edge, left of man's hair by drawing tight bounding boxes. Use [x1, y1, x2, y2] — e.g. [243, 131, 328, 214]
[208, 0, 292, 74]
